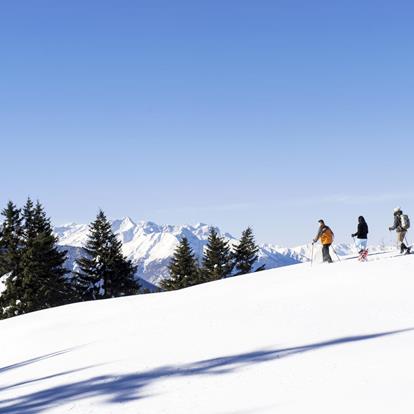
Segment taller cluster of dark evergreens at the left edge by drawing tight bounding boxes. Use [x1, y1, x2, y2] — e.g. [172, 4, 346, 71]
[0, 198, 140, 319]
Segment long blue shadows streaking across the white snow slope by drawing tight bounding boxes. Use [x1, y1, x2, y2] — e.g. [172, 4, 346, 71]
[0, 328, 414, 414]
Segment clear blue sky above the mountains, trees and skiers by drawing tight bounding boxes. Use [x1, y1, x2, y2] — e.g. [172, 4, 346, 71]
[0, 0, 414, 245]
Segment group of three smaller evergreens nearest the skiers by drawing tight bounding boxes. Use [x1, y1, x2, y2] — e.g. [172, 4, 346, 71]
[161, 227, 264, 290]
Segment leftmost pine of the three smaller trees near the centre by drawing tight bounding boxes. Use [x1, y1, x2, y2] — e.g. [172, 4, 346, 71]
[161, 237, 201, 290]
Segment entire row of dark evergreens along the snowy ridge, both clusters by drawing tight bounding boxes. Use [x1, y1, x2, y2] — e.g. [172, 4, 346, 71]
[0, 198, 263, 319]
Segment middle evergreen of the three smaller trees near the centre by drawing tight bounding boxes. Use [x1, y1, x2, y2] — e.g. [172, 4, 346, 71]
[202, 227, 233, 282]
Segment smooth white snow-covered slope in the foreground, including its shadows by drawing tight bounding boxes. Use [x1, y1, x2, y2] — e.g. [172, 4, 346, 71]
[0, 252, 414, 414]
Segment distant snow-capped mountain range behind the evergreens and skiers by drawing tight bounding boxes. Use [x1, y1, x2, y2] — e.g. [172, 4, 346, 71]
[54, 217, 392, 285]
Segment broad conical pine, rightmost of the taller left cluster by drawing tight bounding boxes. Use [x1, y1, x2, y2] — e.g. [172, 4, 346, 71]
[74, 210, 140, 300]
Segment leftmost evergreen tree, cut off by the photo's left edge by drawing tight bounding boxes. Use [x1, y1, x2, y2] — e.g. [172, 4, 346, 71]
[0, 201, 22, 319]
